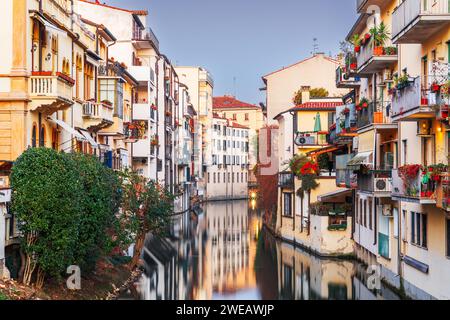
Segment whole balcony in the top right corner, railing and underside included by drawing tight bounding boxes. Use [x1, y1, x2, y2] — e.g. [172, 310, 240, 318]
[392, 0, 450, 43]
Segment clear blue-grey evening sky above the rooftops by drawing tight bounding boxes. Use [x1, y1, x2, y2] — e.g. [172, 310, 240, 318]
[106, 0, 356, 104]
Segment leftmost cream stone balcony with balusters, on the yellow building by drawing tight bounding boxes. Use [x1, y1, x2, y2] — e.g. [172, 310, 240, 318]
[29, 74, 74, 114]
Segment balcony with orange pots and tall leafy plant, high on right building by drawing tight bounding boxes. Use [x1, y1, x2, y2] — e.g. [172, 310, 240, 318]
[356, 38, 398, 76]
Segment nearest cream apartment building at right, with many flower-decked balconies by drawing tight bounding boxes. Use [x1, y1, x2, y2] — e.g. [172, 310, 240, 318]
[342, 0, 450, 299]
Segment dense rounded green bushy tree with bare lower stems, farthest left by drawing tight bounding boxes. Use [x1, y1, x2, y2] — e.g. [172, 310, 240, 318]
[11, 148, 82, 287]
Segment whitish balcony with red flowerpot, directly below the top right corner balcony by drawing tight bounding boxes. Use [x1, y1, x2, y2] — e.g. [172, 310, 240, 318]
[392, 77, 436, 121]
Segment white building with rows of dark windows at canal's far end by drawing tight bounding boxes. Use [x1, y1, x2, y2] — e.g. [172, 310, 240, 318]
[206, 113, 250, 200]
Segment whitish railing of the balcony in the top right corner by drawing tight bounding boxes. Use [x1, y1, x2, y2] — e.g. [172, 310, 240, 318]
[392, 0, 449, 38]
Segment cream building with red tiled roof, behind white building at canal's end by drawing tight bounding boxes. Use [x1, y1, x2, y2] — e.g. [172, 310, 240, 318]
[213, 95, 266, 183]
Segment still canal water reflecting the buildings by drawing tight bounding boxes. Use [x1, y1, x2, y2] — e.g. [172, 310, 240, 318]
[121, 200, 398, 300]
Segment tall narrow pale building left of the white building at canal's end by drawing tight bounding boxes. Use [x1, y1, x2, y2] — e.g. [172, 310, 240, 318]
[175, 66, 214, 197]
